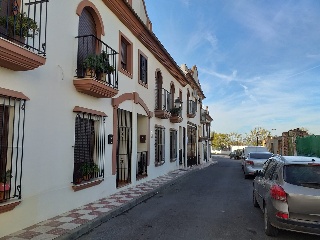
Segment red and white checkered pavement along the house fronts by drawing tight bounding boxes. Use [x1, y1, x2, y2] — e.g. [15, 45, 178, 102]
[0, 161, 216, 240]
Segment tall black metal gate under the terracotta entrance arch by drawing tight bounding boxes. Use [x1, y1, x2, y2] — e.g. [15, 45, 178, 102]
[116, 109, 132, 187]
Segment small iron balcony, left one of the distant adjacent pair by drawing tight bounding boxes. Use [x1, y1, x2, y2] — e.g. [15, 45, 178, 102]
[154, 88, 172, 119]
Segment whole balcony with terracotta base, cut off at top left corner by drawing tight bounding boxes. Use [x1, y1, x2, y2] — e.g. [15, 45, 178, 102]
[0, 0, 49, 71]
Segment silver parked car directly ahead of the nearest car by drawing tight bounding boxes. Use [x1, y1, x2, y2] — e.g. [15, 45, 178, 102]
[242, 152, 273, 178]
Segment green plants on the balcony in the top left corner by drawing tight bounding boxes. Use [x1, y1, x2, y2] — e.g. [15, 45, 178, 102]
[0, 12, 39, 37]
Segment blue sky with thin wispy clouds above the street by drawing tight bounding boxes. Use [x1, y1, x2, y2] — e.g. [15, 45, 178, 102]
[145, 0, 320, 135]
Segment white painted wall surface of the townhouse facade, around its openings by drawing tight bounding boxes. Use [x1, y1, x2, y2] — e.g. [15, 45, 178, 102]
[0, 0, 209, 237]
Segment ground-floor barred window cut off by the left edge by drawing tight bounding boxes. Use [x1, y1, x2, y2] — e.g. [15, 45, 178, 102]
[0, 94, 25, 203]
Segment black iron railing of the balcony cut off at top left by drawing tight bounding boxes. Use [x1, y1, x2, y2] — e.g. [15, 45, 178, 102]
[0, 0, 49, 56]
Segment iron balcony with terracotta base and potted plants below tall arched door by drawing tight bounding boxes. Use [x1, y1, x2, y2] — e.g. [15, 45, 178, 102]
[73, 35, 118, 98]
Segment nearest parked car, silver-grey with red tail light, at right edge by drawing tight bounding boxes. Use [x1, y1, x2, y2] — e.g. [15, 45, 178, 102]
[253, 156, 320, 236]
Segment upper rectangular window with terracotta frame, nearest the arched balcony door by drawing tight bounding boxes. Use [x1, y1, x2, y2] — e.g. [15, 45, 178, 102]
[120, 32, 132, 78]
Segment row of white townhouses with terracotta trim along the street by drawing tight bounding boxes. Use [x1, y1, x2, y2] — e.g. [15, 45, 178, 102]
[0, 0, 212, 237]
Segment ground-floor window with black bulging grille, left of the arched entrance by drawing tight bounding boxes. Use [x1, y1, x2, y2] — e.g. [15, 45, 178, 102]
[73, 107, 105, 184]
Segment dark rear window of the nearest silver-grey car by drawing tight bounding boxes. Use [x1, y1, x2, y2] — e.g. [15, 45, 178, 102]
[284, 164, 320, 189]
